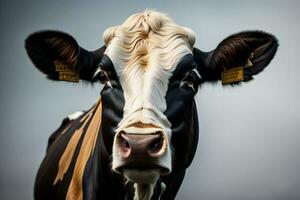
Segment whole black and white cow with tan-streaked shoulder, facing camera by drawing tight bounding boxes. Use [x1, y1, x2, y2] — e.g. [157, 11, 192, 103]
[25, 10, 278, 200]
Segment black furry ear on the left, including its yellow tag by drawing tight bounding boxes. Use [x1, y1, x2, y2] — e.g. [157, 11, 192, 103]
[25, 31, 105, 82]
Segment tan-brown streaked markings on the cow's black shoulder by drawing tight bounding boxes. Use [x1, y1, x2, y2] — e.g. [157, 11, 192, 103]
[53, 99, 102, 200]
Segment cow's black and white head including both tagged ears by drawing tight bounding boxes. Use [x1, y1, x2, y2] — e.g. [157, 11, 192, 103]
[26, 11, 278, 198]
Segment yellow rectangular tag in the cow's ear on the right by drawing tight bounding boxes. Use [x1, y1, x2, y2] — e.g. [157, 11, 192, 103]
[221, 67, 244, 85]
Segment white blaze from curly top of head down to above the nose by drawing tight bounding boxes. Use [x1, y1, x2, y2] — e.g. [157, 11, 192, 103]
[104, 11, 195, 134]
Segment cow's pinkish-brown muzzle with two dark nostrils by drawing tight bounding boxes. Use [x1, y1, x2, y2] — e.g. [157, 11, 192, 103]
[114, 127, 170, 175]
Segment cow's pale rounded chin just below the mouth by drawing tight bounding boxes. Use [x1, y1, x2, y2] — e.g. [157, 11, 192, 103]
[123, 169, 160, 184]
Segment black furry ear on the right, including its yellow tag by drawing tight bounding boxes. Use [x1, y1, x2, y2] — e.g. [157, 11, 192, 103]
[193, 31, 278, 85]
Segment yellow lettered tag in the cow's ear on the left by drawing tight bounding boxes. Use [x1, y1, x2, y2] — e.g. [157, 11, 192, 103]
[54, 60, 79, 82]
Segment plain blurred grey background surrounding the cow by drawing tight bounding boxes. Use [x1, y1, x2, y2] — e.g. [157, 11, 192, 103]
[0, 0, 300, 200]
